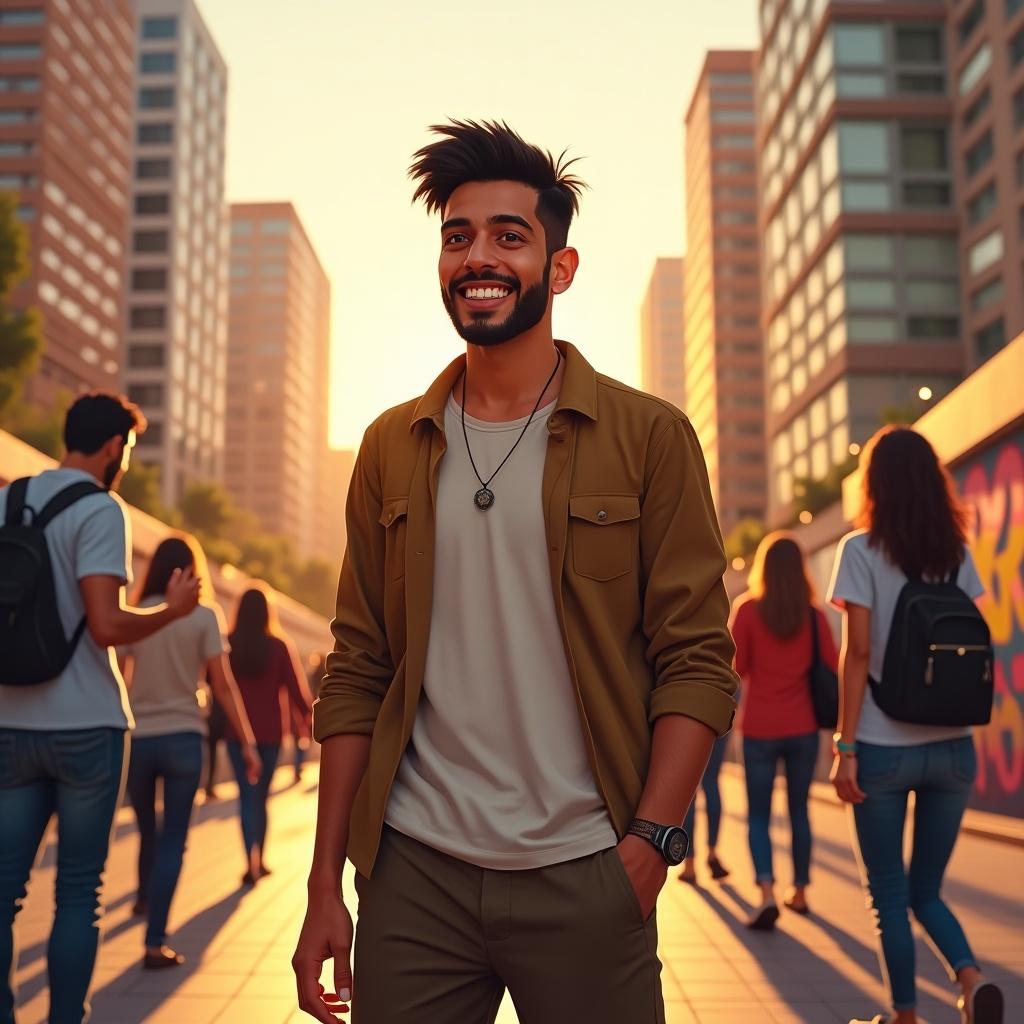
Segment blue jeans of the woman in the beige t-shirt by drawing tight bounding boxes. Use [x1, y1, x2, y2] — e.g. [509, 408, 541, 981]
[128, 732, 203, 947]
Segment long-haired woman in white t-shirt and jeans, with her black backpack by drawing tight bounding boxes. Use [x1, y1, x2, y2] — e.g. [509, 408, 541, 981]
[828, 426, 1004, 1024]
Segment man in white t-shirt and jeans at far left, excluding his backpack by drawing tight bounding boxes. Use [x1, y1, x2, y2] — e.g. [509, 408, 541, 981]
[0, 394, 199, 1024]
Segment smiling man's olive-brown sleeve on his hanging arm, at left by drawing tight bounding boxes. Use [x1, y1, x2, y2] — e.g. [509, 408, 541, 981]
[313, 427, 394, 742]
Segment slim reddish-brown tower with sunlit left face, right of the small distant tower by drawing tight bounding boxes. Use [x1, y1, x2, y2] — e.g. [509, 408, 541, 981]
[684, 50, 766, 532]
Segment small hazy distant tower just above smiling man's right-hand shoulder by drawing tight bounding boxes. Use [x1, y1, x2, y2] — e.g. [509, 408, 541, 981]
[640, 256, 686, 409]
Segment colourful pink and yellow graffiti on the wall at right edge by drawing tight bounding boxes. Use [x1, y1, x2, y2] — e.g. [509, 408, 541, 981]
[955, 430, 1024, 818]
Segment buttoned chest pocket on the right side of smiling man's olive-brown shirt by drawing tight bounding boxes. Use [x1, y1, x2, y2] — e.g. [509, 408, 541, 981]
[569, 495, 640, 580]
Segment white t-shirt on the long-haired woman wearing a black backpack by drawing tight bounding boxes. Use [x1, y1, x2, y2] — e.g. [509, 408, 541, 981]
[828, 529, 985, 746]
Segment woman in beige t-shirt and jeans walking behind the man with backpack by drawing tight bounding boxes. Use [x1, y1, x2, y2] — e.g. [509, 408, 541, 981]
[119, 535, 260, 969]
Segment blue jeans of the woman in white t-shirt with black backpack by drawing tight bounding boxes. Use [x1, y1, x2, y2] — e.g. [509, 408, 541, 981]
[853, 737, 978, 1010]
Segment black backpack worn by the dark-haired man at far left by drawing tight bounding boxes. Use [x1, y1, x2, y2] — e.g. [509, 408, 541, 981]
[0, 477, 105, 686]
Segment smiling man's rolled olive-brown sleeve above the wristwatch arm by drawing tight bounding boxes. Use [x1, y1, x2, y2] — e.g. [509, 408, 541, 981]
[640, 419, 739, 735]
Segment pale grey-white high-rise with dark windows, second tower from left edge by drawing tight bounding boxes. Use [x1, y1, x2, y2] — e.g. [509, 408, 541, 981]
[124, 0, 227, 505]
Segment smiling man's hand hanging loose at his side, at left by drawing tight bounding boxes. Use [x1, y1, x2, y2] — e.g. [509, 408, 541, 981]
[292, 890, 352, 1024]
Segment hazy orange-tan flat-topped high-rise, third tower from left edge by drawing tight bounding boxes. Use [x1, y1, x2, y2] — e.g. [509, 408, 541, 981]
[224, 203, 331, 559]
